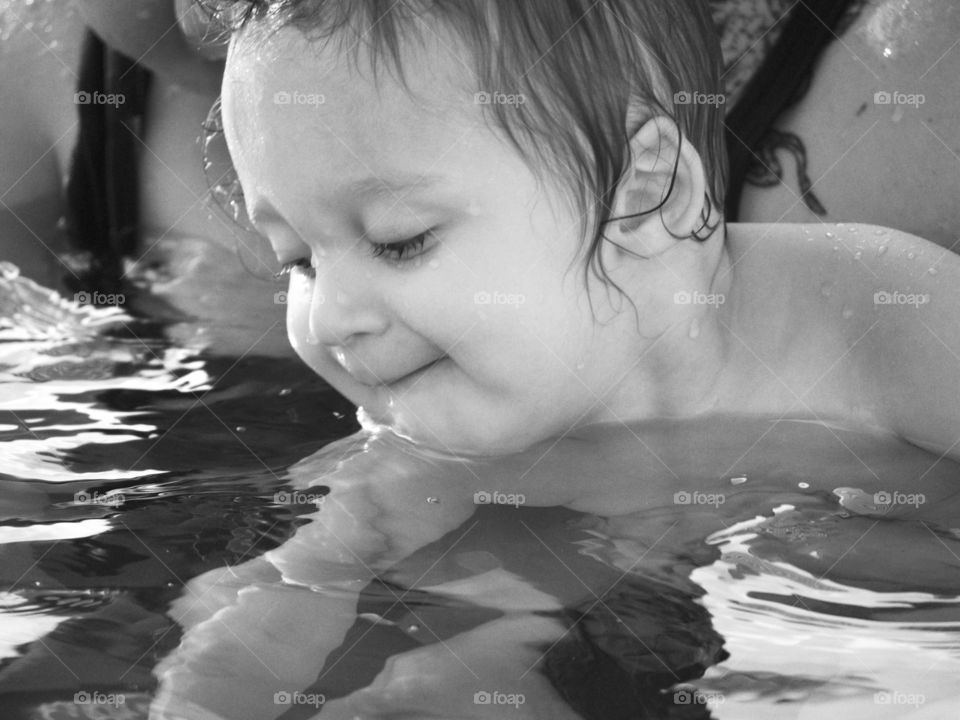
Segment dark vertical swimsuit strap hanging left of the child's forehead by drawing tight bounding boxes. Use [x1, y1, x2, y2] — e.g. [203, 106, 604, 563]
[66, 30, 150, 292]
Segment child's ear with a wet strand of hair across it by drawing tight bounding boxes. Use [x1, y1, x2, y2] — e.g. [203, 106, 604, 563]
[605, 116, 707, 257]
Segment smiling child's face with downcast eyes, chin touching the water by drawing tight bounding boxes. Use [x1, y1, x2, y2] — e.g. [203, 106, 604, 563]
[223, 28, 648, 454]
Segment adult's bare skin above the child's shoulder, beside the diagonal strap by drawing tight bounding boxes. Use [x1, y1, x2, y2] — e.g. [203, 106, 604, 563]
[740, 0, 960, 252]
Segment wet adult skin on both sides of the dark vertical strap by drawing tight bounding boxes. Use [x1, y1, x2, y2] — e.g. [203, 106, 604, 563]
[0, 0, 291, 355]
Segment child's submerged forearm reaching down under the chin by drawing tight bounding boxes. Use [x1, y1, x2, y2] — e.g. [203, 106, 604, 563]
[151, 430, 474, 720]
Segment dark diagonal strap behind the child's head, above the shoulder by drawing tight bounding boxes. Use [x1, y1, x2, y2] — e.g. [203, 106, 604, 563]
[724, 0, 859, 222]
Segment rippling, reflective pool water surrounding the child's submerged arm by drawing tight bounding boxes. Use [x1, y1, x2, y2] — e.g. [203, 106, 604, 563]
[0, 284, 960, 720]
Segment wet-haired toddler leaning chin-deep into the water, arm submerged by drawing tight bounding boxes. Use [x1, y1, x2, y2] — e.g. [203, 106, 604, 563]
[148, 0, 960, 718]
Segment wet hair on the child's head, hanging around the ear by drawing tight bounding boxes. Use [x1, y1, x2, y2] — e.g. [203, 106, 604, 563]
[204, 0, 726, 296]
